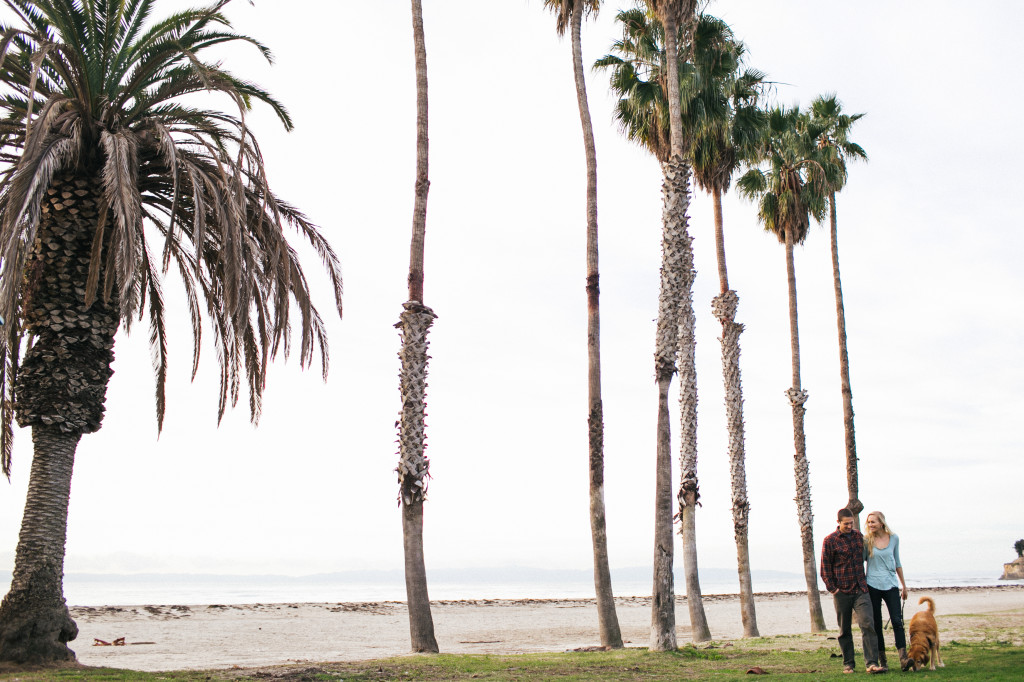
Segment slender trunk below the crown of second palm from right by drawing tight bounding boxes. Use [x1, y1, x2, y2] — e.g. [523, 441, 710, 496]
[785, 227, 825, 632]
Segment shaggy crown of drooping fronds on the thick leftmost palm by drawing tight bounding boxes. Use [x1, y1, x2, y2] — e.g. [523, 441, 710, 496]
[0, 0, 341, 468]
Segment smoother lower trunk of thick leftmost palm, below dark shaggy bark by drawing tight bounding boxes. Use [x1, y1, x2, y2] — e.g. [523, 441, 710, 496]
[0, 425, 82, 664]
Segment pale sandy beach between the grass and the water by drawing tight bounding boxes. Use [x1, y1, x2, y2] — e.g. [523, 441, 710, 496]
[64, 585, 1024, 671]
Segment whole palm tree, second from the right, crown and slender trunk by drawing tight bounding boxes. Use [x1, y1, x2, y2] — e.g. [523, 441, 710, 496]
[737, 108, 827, 632]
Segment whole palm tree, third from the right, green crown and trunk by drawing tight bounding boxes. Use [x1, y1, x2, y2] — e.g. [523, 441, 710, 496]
[684, 15, 764, 637]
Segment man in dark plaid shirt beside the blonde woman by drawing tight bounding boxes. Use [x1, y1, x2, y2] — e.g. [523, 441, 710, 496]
[821, 509, 886, 674]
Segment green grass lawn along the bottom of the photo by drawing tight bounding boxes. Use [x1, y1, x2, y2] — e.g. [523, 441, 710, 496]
[0, 638, 1024, 682]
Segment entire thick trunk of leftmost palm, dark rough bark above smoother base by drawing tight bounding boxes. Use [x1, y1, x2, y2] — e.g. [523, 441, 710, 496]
[0, 175, 119, 664]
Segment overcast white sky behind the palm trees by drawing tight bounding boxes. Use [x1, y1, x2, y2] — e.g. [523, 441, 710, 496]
[0, 0, 1024, 590]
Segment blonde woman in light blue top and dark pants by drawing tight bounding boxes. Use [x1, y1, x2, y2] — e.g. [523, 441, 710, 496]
[864, 511, 906, 669]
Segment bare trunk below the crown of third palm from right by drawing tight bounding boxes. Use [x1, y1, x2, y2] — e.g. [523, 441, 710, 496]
[712, 187, 761, 637]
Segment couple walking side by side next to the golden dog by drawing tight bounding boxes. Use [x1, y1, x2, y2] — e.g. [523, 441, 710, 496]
[821, 509, 906, 674]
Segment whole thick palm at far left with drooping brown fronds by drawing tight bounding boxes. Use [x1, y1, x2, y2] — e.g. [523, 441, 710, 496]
[0, 0, 341, 663]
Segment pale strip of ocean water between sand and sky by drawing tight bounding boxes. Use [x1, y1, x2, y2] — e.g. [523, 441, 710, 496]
[54, 569, 1024, 606]
